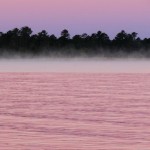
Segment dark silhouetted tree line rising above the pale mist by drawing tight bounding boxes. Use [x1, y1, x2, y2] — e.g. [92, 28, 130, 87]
[0, 26, 150, 56]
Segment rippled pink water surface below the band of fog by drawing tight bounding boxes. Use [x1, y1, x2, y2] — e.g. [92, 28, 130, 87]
[0, 73, 150, 150]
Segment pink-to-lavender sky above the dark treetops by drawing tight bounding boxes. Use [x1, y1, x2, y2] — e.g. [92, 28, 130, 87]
[0, 0, 150, 38]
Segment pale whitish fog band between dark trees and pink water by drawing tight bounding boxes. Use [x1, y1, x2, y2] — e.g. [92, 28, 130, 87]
[0, 58, 150, 73]
